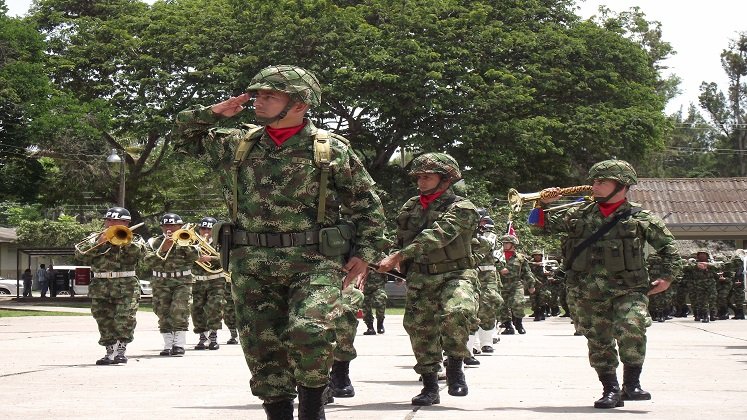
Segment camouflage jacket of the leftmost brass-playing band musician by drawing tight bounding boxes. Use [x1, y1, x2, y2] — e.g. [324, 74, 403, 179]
[75, 235, 147, 273]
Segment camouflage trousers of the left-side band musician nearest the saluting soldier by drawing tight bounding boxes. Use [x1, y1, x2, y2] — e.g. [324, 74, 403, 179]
[192, 277, 226, 334]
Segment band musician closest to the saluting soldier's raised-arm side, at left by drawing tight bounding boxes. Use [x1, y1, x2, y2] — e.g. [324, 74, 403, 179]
[192, 217, 226, 350]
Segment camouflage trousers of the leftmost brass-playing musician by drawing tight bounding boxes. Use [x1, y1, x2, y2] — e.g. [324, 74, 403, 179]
[89, 277, 140, 346]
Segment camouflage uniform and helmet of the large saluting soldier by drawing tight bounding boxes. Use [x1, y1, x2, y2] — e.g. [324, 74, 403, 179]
[177, 66, 384, 411]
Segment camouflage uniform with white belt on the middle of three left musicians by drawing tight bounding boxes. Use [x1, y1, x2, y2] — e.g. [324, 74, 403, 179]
[145, 236, 198, 355]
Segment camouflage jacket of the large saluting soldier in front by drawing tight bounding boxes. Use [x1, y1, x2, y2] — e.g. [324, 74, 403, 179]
[177, 107, 388, 272]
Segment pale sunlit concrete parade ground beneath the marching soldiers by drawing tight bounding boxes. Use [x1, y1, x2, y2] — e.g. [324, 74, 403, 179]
[0, 298, 747, 420]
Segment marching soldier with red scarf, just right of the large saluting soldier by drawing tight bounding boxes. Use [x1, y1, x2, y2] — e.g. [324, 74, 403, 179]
[378, 153, 479, 405]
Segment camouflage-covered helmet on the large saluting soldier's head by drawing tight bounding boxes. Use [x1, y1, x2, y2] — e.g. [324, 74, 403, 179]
[246, 65, 322, 107]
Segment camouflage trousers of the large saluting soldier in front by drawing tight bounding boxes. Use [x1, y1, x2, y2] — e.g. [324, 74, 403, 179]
[232, 271, 341, 403]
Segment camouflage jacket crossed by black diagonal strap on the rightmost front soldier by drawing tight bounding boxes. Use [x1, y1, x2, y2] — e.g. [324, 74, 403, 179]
[544, 202, 680, 298]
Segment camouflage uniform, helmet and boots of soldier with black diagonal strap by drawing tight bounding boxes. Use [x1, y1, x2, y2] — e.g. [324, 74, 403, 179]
[532, 160, 679, 408]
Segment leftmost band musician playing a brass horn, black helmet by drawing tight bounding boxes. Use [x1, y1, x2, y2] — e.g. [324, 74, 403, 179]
[75, 207, 146, 365]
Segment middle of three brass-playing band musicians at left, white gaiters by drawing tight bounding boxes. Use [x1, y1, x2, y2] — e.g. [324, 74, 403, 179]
[145, 213, 199, 356]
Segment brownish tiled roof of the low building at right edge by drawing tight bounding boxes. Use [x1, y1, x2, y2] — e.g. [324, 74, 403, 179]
[628, 178, 747, 225]
